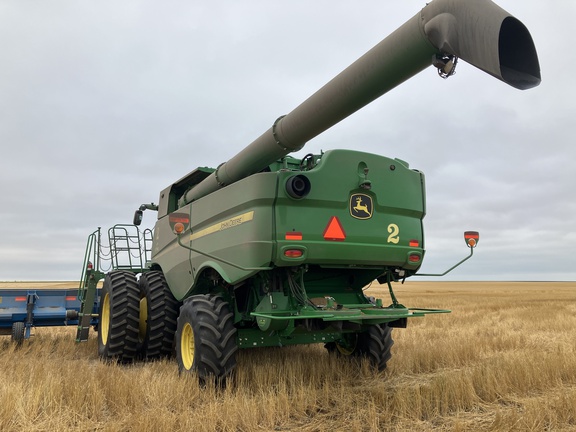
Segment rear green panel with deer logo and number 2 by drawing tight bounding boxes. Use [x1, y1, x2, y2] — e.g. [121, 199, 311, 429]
[274, 150, 425, 270]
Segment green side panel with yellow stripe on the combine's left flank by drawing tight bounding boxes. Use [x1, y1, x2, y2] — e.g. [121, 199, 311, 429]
[152, 173, 276, 299]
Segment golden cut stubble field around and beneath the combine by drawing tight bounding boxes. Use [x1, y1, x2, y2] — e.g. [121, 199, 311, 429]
[0, 282, 576, 431]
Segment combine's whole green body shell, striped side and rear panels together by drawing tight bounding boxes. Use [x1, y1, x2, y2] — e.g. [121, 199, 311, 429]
[153, 150, 425, 299]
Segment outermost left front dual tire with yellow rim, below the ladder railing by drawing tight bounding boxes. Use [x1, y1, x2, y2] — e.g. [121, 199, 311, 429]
[98, 270, 140, 363]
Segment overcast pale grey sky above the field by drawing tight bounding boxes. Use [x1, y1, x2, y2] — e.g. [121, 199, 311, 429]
[0, 0, 576, 281]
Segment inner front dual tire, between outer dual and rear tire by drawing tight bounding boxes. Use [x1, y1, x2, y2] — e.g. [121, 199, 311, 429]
[139, 271, 180, 360]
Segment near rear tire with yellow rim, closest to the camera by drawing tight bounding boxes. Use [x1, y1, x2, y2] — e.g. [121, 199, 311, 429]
[176, 294, 238, 384]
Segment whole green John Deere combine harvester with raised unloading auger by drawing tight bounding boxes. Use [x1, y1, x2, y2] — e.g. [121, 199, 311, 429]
[77, 0, 540, 380]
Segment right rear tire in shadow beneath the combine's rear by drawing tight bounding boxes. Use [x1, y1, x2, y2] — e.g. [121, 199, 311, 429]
[325, 324, 394, 372]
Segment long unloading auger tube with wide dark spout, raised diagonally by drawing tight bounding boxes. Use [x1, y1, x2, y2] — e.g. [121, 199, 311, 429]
[179, 0, 540, 206]
